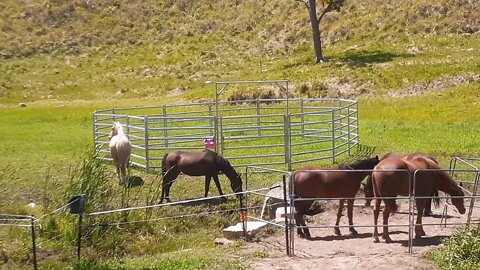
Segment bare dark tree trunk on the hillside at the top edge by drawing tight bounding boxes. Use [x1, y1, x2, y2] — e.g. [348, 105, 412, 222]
[297, 0, 345, 64]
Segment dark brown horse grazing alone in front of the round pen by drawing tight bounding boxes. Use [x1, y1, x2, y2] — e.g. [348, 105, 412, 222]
[160, 150, 242, 203]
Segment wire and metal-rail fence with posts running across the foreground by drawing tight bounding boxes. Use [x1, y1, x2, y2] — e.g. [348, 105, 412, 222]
[0, 158, 480, 269]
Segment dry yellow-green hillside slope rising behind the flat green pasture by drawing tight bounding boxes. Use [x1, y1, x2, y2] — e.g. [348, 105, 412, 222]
[0, 0, 480, 104]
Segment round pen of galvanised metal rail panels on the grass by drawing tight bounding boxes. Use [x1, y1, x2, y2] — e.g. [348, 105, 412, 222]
[93, 98, 359, 172]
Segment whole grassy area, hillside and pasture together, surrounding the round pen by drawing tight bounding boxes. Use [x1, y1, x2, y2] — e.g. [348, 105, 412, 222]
[0, 0, 480, 269]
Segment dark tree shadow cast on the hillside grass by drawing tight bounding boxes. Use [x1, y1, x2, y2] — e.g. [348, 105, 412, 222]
[338, 50, 410, 68]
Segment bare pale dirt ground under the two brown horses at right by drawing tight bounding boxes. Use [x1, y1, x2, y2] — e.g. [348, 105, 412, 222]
[246, 200, 464, 270]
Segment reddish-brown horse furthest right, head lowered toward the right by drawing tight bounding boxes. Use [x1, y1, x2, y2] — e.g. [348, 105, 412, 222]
[372, 156, 465, 243]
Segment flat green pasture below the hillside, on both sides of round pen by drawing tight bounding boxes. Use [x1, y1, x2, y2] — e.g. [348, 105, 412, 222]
[0, 83, 480, 269]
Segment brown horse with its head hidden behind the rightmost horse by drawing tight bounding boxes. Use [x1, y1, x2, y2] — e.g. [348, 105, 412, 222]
[293, 157, 379, 239]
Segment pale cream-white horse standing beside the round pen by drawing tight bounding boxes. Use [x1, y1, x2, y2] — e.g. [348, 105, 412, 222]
[108, 122, 132, 185]
